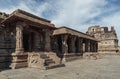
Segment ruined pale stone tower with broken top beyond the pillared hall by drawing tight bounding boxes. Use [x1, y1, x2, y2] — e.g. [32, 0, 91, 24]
[87, 26, 118, 53]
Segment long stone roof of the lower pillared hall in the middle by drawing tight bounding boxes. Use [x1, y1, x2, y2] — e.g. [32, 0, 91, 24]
[53, 26, 98, 41]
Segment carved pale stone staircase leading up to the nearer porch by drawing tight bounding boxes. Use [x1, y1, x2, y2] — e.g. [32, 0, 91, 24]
[28, 52, 65, 69]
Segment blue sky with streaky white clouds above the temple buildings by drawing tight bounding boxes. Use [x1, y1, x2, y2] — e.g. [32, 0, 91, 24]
[0, 0, 120, 44]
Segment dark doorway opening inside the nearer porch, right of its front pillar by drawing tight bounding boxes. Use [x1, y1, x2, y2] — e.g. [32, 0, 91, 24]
[23, 32, 34, 52]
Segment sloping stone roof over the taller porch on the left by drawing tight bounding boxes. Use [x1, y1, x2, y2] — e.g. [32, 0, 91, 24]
[1, 9, 55, 28]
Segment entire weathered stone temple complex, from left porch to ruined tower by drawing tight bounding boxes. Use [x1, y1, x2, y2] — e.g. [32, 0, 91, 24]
[0, 9, 118, 69]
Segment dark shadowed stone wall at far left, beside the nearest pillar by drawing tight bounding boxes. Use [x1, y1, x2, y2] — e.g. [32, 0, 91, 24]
[0, 26, 15, 69]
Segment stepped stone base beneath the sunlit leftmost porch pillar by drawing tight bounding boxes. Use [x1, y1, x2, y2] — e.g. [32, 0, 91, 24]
[10, 53, 28, 69]
